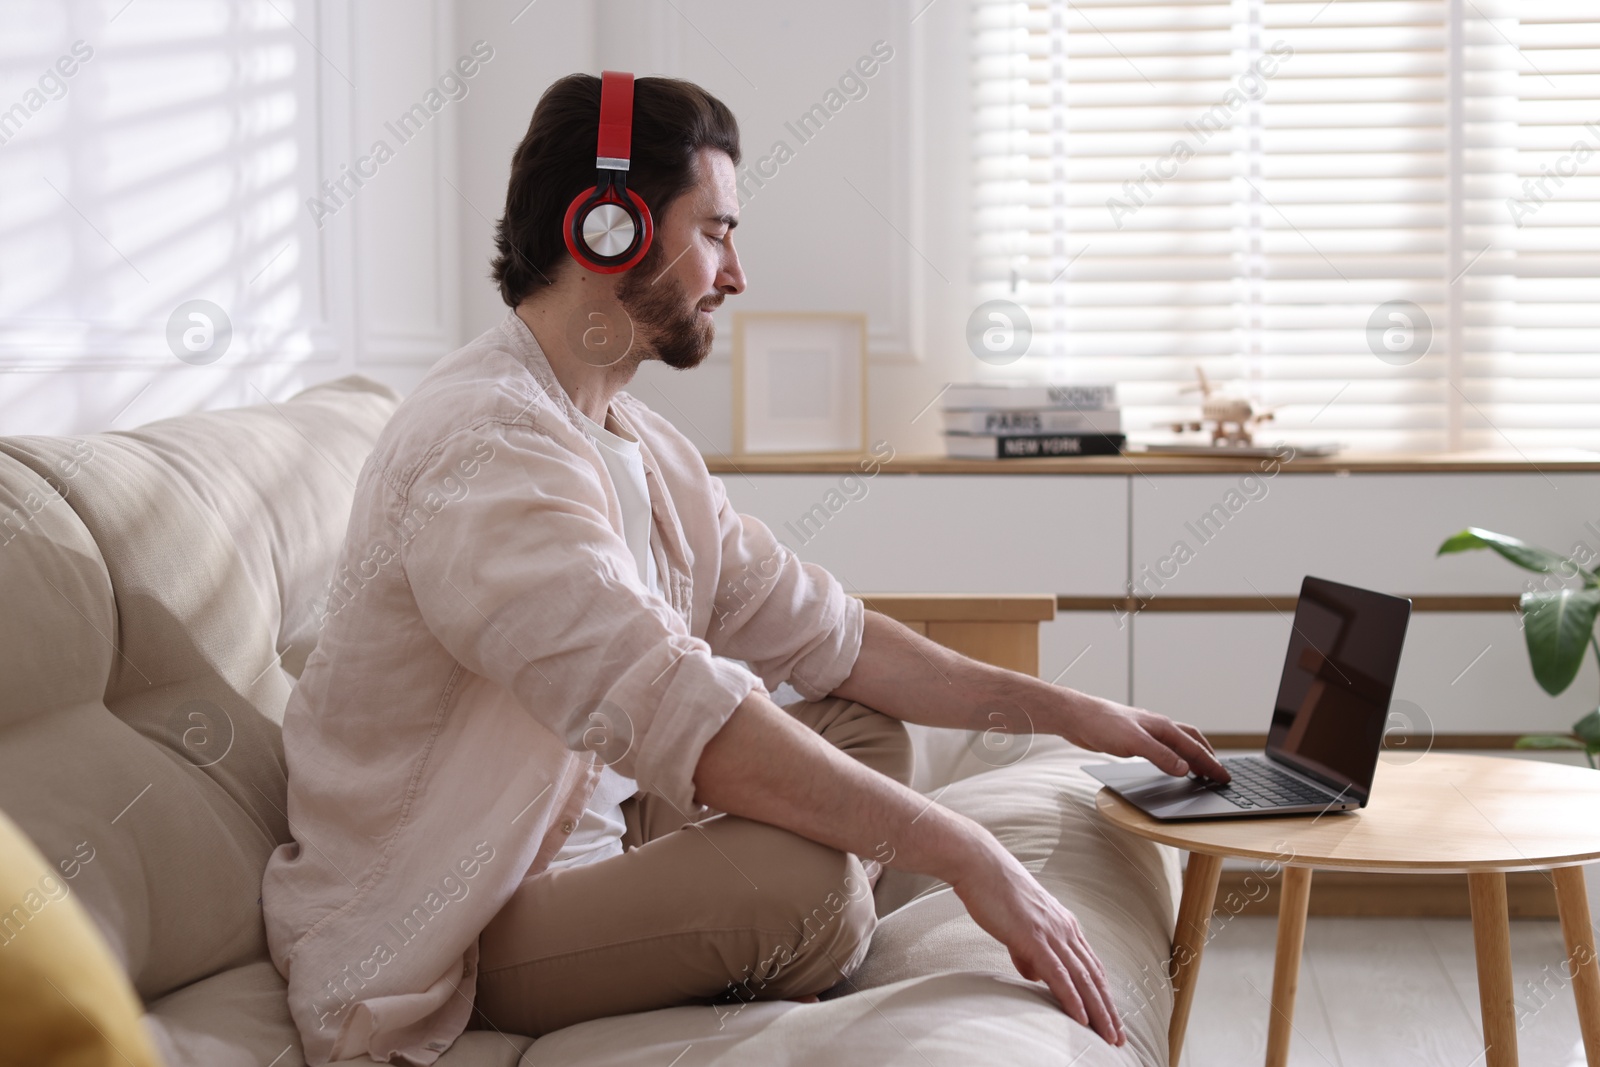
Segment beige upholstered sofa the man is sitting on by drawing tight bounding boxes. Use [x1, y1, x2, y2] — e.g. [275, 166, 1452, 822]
[0, 378, 1178, 1067]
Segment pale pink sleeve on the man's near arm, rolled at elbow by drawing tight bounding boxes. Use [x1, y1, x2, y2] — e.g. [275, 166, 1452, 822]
[395, 424, 760, 813]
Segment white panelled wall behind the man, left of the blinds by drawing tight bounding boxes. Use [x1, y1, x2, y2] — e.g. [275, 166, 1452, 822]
[0, 0, 973, 453]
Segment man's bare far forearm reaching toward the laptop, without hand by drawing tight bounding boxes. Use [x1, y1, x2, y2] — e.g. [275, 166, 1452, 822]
[834, 609, 1069, 729]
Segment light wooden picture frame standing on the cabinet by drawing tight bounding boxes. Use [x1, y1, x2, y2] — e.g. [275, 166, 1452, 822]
[733, 312, 867, 456]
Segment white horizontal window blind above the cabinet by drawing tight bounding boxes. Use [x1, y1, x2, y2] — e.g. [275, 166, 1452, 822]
[973, 0, 1600, 451]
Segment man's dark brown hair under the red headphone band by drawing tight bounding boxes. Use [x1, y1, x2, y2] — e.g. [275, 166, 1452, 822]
[491, 74, 739, 307]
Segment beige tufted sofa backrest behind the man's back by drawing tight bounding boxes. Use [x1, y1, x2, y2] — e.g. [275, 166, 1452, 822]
[0, 379, 398, 1000]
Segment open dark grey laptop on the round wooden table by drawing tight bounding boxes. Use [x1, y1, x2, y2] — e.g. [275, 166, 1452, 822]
[1083, 577, 1411, 819]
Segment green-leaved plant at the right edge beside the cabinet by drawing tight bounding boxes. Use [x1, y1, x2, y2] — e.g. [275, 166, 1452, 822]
[1437, 526, 1600, 768]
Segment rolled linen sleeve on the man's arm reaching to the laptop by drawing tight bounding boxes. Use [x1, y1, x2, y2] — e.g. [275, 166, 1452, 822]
[706, 477, 866, 701]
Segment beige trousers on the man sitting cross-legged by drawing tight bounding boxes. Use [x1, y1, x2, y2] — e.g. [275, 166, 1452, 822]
[469, 697, 912, 1037]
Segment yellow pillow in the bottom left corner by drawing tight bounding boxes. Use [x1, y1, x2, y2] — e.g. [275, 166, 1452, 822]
[0, 813, 162, 1067]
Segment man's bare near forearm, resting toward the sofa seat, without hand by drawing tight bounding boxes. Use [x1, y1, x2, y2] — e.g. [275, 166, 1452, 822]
[694, 689, 998, 881]
